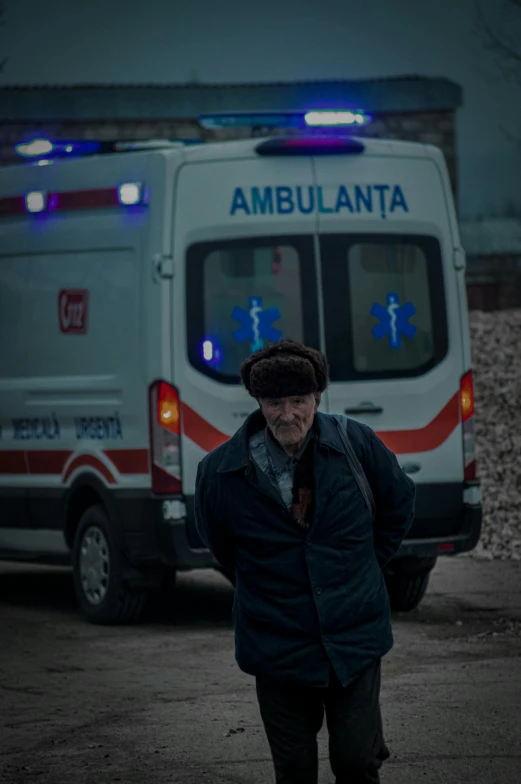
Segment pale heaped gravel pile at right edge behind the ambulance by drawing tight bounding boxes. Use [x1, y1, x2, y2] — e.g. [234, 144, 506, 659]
[469, 310, 521, 561]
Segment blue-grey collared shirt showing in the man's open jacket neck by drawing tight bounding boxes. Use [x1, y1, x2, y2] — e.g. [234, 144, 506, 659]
[249, 426, 313, 509]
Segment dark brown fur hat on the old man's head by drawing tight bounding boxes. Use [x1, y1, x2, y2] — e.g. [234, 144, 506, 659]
[241, 340, 328, 399]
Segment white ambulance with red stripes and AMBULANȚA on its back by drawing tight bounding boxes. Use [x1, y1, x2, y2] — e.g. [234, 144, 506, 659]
[0, 136, 482, 622]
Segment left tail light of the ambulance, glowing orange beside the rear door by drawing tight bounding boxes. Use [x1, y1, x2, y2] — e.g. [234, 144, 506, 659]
[149, 381, 183, 495]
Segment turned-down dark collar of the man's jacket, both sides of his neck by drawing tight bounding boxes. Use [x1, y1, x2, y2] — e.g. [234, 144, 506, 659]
[217, 408, 344, 474]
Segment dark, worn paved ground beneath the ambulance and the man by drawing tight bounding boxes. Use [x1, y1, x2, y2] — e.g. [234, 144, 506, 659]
[0, 558, 521, 784]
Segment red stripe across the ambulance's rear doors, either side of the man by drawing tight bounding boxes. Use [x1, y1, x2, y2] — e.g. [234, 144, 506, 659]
[183, 392, 460, 455]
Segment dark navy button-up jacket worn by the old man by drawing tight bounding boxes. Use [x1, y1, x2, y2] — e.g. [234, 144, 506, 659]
[195, 410, 415, 686]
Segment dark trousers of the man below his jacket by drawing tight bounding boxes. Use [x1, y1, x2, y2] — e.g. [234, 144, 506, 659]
[257, 661, 390, 784]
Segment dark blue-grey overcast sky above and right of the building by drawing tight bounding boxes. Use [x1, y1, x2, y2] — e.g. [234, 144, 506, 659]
[0, 0, 521, 218]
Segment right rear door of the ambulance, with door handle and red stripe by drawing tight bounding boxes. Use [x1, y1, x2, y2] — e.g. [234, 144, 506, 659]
[314, 153, 464, 483]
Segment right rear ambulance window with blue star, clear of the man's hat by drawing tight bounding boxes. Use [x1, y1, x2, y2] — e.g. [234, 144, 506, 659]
[320, 235, 447, 381]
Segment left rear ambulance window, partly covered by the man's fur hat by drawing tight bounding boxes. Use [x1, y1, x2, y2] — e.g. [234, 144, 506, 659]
[186, 236, 318, 384]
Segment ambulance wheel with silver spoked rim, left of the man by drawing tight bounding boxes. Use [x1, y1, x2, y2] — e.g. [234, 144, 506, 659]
[72, 505, 146, 624]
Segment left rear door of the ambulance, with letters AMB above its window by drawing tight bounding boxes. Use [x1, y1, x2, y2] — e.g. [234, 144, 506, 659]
[173, 153, 319, 500]
